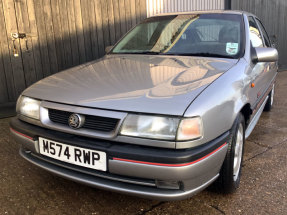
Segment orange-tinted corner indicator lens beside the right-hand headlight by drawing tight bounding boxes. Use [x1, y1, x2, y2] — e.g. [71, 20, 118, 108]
[176, 117, 203, 141]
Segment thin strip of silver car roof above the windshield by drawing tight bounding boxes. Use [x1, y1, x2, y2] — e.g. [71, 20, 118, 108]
[152, 10, 255, 17]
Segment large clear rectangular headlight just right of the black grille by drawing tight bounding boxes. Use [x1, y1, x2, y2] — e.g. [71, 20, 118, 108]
[120, 115, 179, 140]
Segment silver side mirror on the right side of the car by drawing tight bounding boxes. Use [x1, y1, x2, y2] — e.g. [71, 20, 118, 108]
[253, 47, 278, 62]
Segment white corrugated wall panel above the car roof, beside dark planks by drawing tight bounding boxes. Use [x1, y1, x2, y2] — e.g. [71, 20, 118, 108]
[146, 0, 224, 17]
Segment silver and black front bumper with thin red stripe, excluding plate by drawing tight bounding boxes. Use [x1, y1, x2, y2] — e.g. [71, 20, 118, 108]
[10, 117, 229, 201]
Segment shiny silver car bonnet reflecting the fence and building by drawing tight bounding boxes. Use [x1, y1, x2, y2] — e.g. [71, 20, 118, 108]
[23, 55, 237, 116]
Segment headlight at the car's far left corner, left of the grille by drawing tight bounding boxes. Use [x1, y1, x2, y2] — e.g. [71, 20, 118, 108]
[16, 96, 41, 119]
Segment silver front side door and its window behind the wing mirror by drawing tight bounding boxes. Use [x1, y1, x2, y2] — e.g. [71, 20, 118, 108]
[248, 16, 270, 113]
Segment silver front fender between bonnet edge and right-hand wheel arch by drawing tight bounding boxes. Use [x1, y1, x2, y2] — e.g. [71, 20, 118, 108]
[176, 59, 250, 148]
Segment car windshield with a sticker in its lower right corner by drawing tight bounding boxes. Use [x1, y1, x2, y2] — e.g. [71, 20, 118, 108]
[111, 14, 244, 58]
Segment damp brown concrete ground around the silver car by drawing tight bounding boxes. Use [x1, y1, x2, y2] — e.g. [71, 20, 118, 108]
[0, 71, 287, 215]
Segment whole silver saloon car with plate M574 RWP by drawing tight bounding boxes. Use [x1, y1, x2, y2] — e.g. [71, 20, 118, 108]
[10, 11, 278, 200]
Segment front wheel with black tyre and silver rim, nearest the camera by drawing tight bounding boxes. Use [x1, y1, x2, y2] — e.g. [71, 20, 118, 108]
[216, 113, 245, 194]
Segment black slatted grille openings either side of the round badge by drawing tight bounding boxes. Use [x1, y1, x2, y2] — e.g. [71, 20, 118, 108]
[49, 109, 119, 132]
